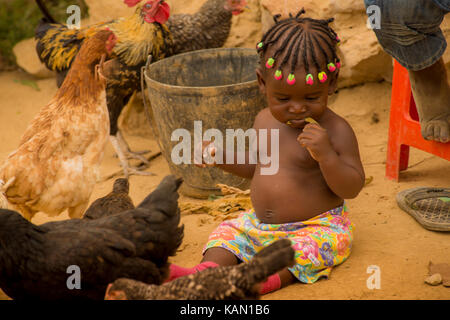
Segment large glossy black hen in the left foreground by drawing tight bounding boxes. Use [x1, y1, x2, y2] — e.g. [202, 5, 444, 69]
[0, 176, 183, 300]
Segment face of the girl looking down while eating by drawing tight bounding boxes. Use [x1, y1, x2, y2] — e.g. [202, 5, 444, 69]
[256, 68, 337, 129]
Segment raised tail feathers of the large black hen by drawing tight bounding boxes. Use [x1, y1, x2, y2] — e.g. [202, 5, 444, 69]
[138, 175, 183, 216]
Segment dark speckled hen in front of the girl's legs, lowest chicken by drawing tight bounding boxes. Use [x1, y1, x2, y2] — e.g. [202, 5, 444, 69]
[105, 239, 295, 300]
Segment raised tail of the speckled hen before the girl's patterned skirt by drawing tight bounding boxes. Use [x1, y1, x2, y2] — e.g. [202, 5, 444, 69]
[243, 239, 295, 283]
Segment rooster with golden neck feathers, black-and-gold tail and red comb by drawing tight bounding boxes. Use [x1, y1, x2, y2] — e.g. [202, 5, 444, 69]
[35, 0, 172, 178]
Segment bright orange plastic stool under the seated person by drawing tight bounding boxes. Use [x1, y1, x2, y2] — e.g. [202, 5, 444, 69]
[386, 61, 450, 181]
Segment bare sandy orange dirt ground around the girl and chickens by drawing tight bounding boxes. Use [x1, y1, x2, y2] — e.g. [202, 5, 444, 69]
[0, 71, 450, 300]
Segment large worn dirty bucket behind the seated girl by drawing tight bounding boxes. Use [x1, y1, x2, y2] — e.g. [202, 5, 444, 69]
[144, 48, 266, 198]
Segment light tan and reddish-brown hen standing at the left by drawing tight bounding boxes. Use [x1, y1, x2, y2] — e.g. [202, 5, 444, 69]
[0, 30, 116, 220]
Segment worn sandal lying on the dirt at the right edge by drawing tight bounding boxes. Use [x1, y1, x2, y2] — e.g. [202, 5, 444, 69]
[396, 187, 450, 231]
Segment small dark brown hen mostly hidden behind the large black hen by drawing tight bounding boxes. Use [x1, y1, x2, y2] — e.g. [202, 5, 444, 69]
[83, 178, 134, 220]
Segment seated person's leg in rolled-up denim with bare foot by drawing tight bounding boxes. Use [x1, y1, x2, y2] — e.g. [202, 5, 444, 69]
[364, 0, 450, 142]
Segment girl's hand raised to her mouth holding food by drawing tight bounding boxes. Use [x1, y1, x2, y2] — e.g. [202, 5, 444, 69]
[297, 123, 335, 162]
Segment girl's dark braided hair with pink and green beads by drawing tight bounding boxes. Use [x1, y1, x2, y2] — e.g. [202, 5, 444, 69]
[257, 9, 341, 85]
